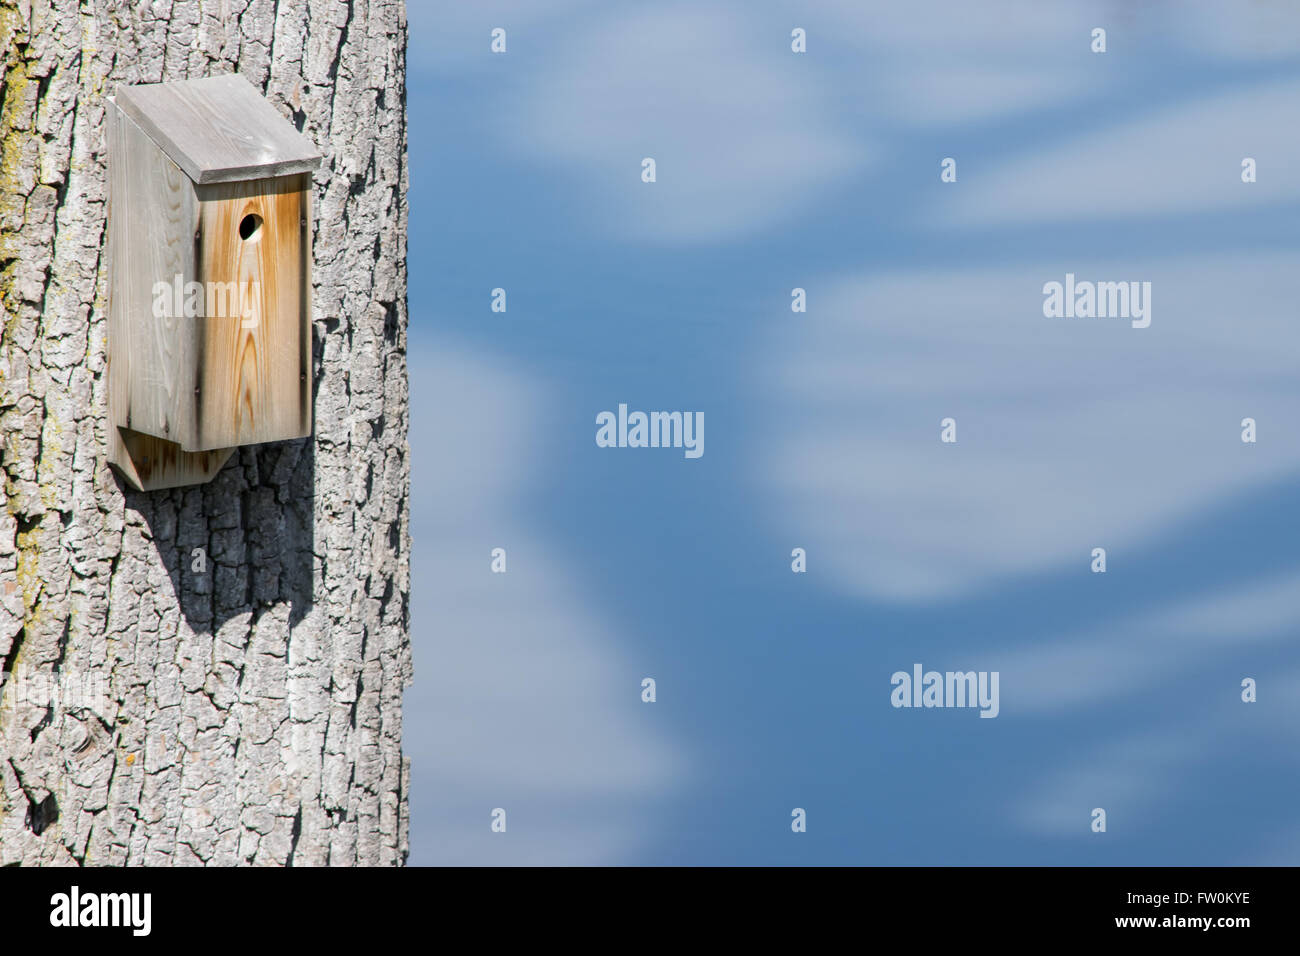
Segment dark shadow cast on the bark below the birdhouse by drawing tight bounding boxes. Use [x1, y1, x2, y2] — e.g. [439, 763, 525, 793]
[131, 437, 316, 633]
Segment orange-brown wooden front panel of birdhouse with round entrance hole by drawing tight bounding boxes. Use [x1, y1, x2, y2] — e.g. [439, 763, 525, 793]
[186, 174, 312, 451]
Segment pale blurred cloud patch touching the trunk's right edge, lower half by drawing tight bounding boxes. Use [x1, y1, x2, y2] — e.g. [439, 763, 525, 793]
[404, 343, 686, 865]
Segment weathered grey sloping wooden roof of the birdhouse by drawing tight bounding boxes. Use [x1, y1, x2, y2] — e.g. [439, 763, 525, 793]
[116, 73, 321, 183]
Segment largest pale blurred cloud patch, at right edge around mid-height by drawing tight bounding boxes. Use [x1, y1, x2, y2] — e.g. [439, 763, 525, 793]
[753, 254, 1300, 601]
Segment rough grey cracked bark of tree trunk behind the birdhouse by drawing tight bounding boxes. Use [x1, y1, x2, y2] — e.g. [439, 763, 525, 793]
[0, 0, 411, 865]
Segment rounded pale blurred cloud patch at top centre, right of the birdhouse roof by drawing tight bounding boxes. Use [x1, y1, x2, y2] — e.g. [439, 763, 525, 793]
[495, 4, 872, 241]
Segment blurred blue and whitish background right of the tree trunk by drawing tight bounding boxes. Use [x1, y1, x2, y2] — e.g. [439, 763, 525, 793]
[404, 0, 1300, 865]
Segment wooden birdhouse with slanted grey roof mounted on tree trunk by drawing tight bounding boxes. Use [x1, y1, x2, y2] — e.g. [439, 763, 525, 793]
[105, 74, 321, 490]
